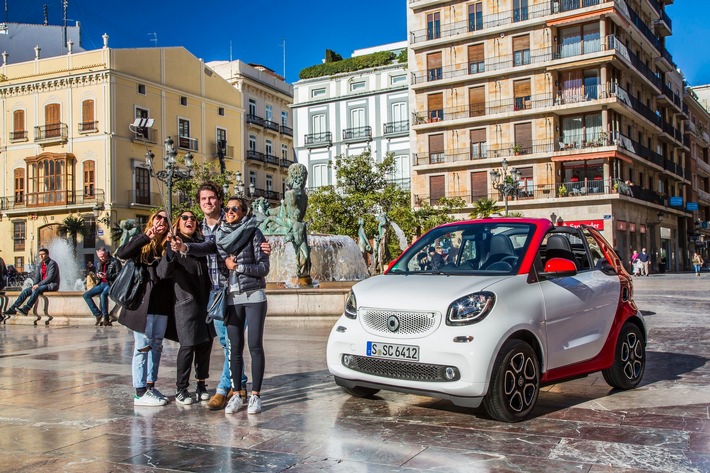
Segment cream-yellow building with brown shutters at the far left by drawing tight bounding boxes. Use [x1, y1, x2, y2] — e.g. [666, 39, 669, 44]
[0, 42, 244, 271]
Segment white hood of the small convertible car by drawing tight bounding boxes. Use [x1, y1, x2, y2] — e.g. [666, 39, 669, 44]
[353, 274, 511, 313]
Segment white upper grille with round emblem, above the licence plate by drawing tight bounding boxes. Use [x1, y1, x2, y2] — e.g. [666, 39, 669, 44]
[362, 308, 439, 337]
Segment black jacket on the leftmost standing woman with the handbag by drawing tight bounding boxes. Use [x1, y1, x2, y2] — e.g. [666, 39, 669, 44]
[116, 233, 175, 333]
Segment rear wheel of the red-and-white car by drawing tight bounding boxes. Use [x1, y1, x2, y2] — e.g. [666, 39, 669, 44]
[602, 322, 646, 389]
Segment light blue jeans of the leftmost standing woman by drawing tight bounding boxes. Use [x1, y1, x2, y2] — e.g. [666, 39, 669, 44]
[132, 314, 168, 388]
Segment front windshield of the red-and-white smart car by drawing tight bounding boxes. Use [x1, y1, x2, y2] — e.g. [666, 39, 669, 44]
[389, 220, 534, 274]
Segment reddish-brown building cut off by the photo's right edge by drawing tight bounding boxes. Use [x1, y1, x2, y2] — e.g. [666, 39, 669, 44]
[685, 86, 710, 261]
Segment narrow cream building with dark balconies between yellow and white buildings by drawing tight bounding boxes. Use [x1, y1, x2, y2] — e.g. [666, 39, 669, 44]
[207, 60, 294, 200]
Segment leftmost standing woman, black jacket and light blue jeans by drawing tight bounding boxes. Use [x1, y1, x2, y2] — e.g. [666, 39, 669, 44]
[116, 210, 175, 406]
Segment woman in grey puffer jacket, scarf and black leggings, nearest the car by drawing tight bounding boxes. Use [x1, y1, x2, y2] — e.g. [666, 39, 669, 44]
[216, 197, 269, 414]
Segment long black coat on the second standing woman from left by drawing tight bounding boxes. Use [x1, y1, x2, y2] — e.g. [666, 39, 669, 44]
[157, 236, 214, 346]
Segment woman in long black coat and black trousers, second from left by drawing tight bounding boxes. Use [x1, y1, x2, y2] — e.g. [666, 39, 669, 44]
[158, 210, 214, 404]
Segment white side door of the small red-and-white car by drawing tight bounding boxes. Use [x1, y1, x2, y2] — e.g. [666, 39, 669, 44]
[539, 229, 620, 369]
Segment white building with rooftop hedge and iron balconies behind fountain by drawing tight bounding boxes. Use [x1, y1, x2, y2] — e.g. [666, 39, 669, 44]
[293, 41, 411, 189]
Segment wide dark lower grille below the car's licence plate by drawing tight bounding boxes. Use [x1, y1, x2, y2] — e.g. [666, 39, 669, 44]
[341, 355, 460, 382]
